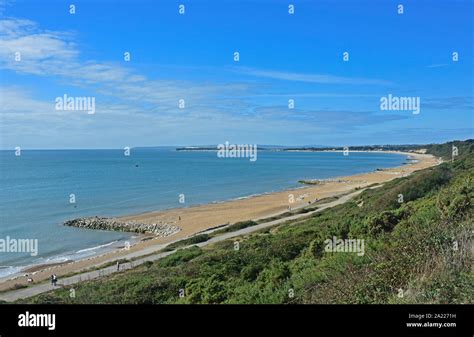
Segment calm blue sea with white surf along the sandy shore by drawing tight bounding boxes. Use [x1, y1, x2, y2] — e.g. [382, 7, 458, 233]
[0, 148, 406, 277]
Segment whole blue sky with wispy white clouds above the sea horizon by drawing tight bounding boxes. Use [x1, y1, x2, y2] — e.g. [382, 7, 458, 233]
[0, 0, 474, 149]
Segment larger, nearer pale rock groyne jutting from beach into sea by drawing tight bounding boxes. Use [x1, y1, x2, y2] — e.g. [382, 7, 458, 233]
[64, 216, 181, 237]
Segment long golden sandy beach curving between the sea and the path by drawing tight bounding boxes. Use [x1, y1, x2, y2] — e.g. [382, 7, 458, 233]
[0, 151, 439, 291]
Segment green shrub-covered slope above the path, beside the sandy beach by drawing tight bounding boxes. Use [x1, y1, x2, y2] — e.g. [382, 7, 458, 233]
[23, 142, 474, 303]
